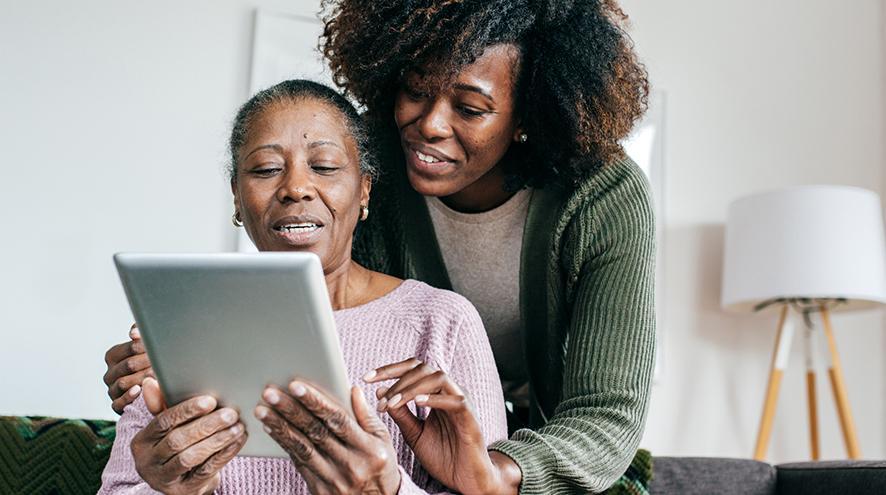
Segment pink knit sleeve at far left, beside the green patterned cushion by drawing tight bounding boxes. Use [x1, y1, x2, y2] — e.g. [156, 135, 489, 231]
[98, 396, 160, 495]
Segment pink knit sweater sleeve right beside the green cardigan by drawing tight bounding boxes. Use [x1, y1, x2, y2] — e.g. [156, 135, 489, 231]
[398, 301, 508, 495]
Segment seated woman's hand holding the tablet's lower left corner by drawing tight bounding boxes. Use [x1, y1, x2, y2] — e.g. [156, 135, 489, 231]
[131, 378, 247, 494]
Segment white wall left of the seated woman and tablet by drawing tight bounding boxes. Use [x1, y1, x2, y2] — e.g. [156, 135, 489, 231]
[0, 0, 314, 417]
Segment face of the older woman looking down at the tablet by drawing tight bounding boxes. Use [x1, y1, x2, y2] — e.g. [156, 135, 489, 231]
[231, 98, 371, 273]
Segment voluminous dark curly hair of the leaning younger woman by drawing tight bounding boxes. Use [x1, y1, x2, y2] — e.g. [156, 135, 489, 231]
[320, 0, 649, 185]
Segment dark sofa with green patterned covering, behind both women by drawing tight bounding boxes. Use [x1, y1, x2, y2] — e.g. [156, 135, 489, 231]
[0, 416, 886, 495]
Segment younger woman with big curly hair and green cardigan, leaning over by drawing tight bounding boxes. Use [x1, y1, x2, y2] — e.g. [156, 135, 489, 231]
[106, 0, 655, 494]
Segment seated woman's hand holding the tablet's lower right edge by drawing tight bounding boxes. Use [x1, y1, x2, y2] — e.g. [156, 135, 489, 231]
[255, 381, 400, 494]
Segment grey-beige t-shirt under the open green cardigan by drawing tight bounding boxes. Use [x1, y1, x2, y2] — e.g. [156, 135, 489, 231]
[425, 189, 532, 407]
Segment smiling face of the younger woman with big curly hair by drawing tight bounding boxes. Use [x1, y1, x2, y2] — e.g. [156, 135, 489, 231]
[394, 44, 520, 201]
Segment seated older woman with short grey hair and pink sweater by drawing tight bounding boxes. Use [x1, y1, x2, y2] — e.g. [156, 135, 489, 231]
[101, 81, 506, 494]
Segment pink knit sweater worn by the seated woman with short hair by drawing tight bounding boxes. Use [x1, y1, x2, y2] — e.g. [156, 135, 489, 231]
[99, 280, 507, 495]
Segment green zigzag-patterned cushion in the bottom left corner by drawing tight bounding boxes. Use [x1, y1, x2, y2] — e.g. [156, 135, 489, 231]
[0, 416, 116, 495]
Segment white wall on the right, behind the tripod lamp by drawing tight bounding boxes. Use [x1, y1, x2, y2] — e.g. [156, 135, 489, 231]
[622, 0, 886, 462]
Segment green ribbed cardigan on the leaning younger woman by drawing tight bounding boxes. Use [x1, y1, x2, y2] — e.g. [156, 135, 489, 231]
[353, 134, 655, 494]
